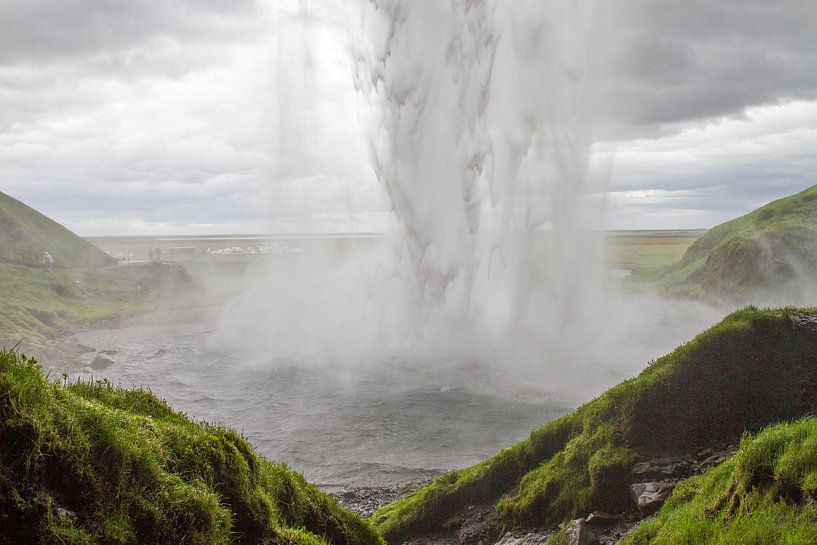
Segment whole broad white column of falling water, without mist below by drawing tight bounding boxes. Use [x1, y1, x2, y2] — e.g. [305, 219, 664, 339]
[354, 0, 603, 378]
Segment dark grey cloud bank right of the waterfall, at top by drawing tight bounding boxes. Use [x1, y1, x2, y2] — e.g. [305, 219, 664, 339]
[598, 0, 817, 138]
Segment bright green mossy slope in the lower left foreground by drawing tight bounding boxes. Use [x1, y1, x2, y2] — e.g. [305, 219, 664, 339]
[0, 352, 381, 545]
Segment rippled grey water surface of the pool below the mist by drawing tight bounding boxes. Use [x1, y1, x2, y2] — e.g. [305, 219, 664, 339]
[77, 317, 567, 485]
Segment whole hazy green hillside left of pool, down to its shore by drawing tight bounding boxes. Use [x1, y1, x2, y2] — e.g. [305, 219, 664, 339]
[0, 193, 198, 352]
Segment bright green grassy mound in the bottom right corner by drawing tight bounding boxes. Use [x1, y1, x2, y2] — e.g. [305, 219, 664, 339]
[622, 418, 817, 545]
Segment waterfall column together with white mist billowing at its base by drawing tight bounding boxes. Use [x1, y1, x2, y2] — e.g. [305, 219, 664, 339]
[224, 0, 676, 392]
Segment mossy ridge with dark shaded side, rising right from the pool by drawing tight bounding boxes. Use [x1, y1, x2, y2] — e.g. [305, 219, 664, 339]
[372, 307, 817, 542]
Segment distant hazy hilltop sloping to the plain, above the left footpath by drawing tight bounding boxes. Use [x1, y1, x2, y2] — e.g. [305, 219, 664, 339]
[0, 192, 116, 268]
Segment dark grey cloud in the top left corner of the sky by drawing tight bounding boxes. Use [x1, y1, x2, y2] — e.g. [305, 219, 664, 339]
[0, 0, 269, 132]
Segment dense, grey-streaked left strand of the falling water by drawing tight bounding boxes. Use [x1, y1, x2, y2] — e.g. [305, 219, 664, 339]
[350, 1, 497, 318]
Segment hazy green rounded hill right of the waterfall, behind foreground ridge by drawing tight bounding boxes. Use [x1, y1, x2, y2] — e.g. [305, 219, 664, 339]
[642, 186, 817, 304]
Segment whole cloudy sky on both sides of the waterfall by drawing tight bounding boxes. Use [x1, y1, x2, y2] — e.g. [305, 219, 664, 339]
[0, 0, 817, 235]
